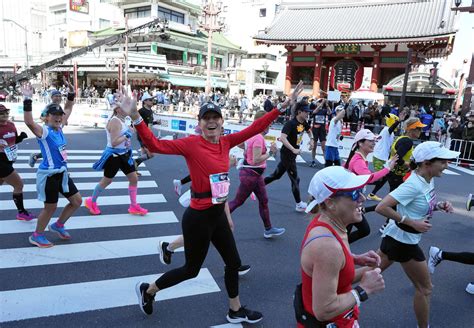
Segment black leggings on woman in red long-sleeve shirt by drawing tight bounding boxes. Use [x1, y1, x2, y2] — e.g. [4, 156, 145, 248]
[155, 204, 241, 298]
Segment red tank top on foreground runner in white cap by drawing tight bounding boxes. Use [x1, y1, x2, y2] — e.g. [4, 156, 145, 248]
[298, 215, 359, 328]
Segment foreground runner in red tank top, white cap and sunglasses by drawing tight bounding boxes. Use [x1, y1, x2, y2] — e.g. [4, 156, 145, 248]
[294, 166, 385, 328]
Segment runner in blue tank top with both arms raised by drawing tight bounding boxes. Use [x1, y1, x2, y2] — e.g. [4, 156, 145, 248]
[21, 82, 82, 248]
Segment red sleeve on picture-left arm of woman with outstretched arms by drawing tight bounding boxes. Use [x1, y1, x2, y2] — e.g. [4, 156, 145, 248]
[135, 121, 188, 156]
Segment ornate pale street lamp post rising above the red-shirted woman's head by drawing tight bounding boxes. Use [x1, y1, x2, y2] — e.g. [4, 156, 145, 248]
[199, 0, 224, 95]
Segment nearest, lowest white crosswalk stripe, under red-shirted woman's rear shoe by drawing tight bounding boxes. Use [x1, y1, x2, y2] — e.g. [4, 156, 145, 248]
[0, 268, 220, 322]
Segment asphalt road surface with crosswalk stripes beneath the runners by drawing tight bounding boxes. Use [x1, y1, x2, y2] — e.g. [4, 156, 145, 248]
[0, 127, 474, 328]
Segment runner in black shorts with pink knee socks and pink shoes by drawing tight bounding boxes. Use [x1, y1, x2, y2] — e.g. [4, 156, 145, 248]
[84, 98, 148, 215]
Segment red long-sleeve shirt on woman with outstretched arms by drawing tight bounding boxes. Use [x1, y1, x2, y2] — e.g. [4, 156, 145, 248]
[136, 109, 280, 210]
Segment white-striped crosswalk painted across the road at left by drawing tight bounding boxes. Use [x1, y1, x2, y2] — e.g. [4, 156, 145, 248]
[0, 149, 221, 326]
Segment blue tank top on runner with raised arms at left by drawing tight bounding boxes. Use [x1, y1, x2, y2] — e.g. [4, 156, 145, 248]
[36, 125, 67, 170]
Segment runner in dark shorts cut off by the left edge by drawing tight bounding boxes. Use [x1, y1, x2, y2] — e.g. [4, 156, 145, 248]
[0, 104, 36, 221]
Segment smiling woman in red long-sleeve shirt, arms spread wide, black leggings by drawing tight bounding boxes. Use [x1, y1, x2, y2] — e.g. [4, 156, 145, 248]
[120, 83, 302, 323]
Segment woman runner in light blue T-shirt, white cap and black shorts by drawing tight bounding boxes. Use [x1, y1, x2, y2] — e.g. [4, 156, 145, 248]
[375, 141, 459, 328]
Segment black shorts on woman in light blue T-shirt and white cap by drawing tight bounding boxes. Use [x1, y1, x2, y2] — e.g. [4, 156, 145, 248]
[380, 236, 426, 263]
